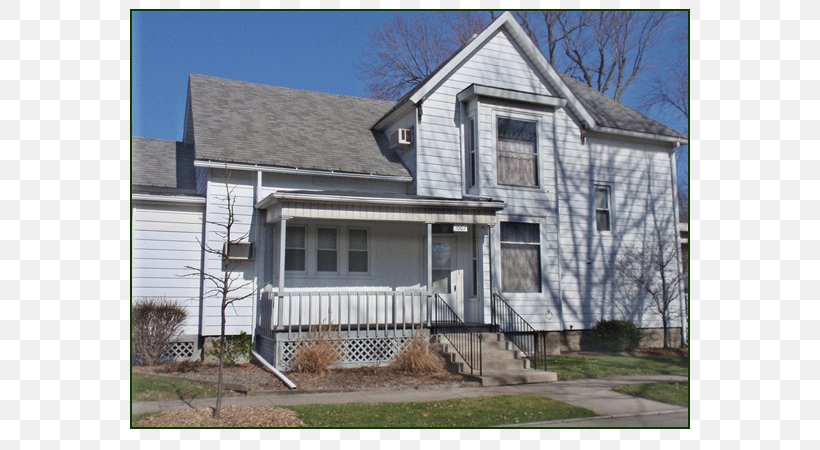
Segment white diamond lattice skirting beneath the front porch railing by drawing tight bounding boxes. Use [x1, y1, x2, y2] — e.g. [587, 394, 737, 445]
[276, 336, 413, 370]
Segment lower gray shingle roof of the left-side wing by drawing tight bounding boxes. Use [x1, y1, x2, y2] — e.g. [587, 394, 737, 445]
[131, 137, 196, 193]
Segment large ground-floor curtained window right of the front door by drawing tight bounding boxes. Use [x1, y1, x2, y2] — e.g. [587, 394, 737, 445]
[501, 222, 541, 292]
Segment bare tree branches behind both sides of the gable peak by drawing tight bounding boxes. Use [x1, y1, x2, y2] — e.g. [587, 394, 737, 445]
[359, 11, 668, 100]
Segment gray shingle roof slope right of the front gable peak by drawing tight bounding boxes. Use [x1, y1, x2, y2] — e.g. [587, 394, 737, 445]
[560, 74, 686, 139]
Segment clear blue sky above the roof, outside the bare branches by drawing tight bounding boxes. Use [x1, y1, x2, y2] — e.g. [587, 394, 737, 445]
[132, 11, 688, 140]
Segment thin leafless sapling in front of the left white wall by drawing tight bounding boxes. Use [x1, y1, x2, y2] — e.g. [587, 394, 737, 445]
[185, 173, 254, 419]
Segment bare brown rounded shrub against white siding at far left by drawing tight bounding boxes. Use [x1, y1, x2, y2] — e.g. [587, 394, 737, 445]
[131, 297, 186, 365]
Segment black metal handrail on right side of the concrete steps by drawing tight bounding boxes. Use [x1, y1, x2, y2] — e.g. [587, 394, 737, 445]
[490, 293, 547, 370]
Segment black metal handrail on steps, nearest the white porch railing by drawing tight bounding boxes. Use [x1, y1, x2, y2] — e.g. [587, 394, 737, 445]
[427, 294, 484, 376]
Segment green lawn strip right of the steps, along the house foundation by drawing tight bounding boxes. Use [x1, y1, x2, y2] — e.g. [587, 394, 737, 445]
[547, 355, 689, 381]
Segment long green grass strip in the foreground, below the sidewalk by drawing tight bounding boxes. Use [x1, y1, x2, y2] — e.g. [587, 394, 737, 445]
[288, 395, 595, 428]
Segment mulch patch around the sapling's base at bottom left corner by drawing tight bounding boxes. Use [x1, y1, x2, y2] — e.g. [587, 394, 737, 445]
[137, 406, 305, 428]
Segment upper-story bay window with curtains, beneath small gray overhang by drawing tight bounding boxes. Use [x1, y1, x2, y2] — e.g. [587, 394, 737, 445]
[496, 117, 538, 187]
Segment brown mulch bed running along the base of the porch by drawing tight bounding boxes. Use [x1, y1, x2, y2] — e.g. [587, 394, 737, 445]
[133, 362, 478, 394]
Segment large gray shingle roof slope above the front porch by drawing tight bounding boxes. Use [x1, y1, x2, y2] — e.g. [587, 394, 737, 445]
[189, 75, 410, 176]
